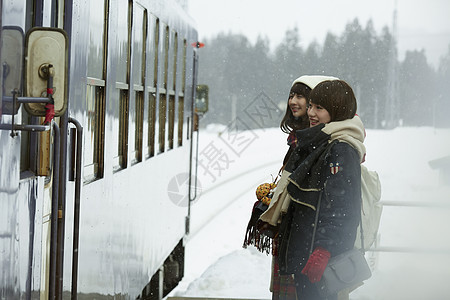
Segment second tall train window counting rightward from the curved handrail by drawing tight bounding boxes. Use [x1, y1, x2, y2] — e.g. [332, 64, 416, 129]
[110, 1, 132, 171]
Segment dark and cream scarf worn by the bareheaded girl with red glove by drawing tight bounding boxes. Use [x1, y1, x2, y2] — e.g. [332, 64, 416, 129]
[259, 116, 366, 226]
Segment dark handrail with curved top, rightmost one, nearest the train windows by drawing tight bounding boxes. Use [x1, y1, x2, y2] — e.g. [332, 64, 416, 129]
[69, 117, 83, 300]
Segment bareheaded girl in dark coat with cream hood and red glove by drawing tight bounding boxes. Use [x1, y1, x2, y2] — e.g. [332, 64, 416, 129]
[262, 80, 365, 300]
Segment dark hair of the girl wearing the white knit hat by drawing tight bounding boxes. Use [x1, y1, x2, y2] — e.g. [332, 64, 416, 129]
[280, 82, 311, 133]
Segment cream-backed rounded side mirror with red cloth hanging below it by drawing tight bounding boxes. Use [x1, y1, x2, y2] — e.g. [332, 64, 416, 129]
[24, 27, 68, 116]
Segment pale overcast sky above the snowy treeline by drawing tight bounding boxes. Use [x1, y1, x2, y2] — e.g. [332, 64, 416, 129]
[188, 0, 450, 66]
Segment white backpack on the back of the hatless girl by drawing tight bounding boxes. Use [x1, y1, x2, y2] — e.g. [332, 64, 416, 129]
[355, 165, 383, 250]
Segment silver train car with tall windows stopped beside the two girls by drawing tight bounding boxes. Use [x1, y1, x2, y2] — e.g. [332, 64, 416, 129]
[0, 0, 205, 299]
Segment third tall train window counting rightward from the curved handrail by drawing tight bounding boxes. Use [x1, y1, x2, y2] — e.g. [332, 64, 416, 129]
[129, 4, 147, 163]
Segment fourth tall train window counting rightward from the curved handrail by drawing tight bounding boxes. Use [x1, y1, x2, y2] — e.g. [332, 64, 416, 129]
[147, 14, 159, 157]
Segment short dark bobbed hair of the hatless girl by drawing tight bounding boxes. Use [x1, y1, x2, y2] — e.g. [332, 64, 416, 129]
[309, 80, 357, 122]
